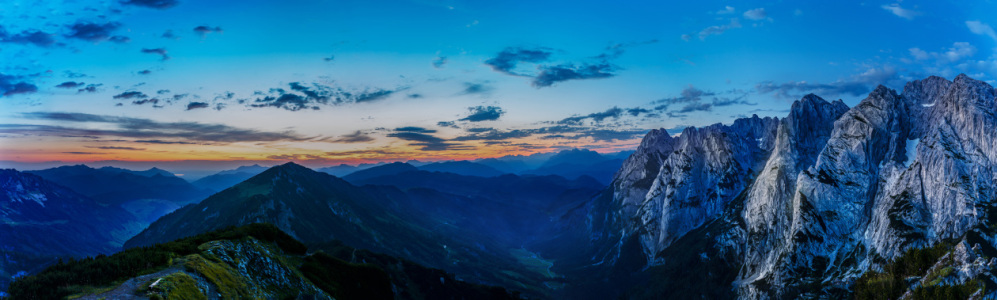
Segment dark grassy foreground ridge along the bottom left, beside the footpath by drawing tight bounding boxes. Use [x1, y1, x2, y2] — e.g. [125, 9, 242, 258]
[3, 224, 518, 299]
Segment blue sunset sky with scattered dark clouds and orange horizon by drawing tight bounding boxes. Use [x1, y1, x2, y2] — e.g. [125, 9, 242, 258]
[0, 0, 997, 171]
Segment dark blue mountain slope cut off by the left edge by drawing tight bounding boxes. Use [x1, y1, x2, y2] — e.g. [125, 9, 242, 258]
[0, 169, 142, 291]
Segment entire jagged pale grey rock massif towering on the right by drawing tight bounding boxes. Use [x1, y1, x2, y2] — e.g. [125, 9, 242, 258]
[612, 75, 997, 298]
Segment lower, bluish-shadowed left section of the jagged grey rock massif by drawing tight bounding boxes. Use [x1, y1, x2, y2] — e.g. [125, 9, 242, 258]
[612, 116, 779, 260]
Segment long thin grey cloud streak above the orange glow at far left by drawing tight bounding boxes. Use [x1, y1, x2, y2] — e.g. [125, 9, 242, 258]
[14, 112, 315, 143]
